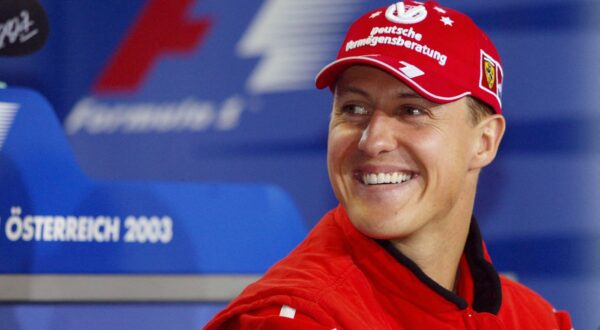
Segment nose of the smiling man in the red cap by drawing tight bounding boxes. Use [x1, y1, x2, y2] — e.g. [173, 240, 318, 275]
[358, 110, 398, 157]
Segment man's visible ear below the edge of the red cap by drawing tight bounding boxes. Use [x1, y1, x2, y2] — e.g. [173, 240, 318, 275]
[471, 114, 506, 169]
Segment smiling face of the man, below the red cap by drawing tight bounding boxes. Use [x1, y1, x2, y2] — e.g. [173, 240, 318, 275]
[327, 66, 486, 239]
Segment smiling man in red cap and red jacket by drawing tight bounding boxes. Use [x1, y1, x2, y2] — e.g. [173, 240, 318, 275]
[207, 1, 571, 330]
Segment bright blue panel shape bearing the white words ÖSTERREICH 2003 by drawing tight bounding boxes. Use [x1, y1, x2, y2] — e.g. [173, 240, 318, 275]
[0, 88, 306, 274]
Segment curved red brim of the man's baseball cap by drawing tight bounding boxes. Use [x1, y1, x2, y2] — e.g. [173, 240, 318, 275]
[315, 55, 471, 103]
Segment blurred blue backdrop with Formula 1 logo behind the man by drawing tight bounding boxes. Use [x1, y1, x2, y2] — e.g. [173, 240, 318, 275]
[0, 0, 600, 329]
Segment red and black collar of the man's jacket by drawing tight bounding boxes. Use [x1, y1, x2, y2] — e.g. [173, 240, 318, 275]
[335, 206, 502, 315]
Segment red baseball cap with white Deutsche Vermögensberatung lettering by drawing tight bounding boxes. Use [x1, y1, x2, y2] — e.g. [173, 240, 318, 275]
[316, 1, 504, 113]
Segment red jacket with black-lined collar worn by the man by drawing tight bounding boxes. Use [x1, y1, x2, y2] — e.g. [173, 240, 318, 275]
[205, 207, 571, 330]
